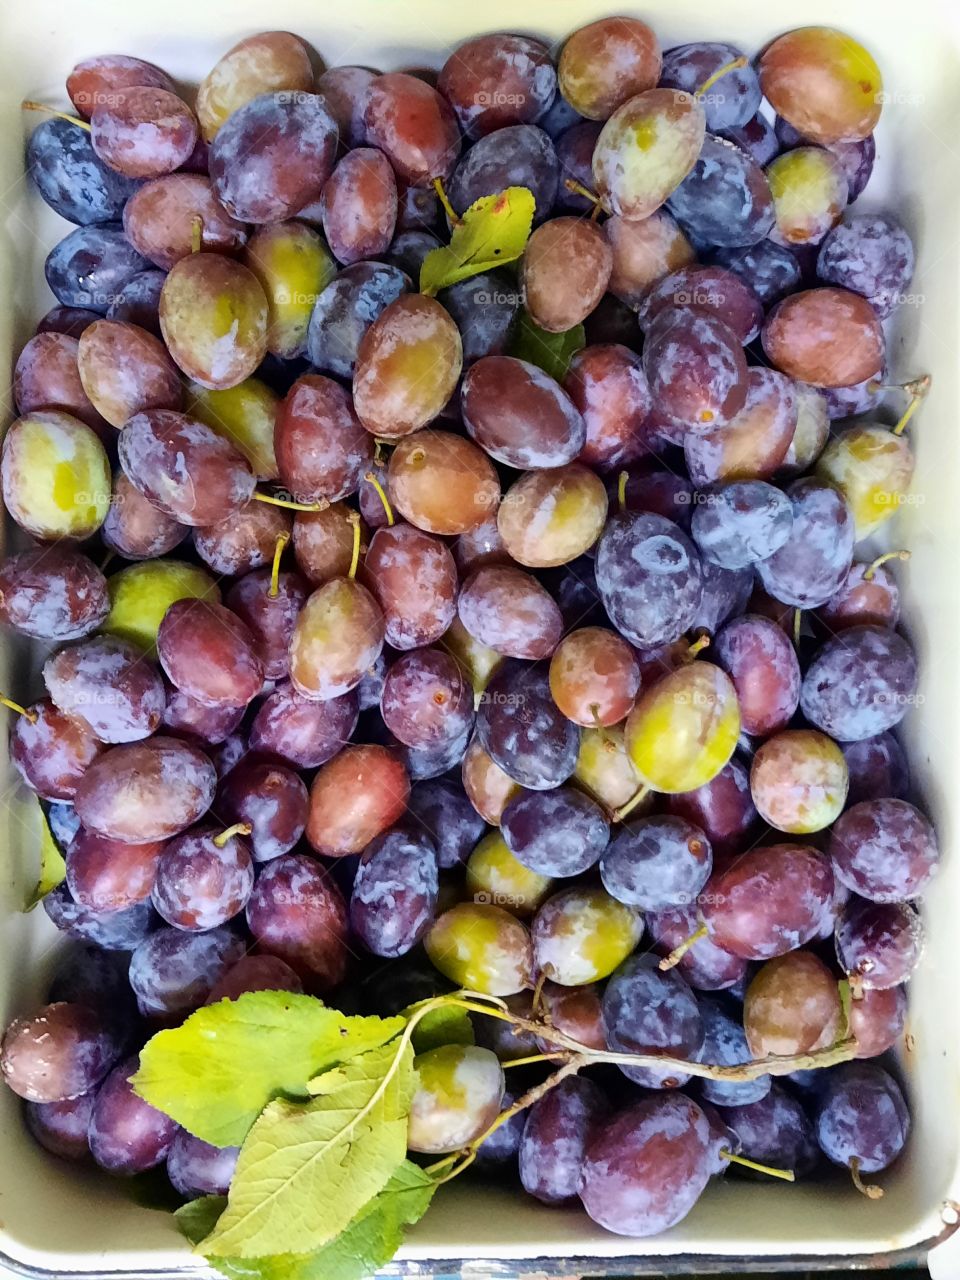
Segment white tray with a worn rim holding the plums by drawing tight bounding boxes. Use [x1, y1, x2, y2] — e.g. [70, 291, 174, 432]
[0, 0, 960, 1275]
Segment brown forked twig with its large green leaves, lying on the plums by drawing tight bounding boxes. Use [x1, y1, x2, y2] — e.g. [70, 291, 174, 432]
[132, 991, 856, 1280]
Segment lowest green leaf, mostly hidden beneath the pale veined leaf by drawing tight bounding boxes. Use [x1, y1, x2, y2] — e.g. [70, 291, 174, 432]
[177, 1160, 438, 1280]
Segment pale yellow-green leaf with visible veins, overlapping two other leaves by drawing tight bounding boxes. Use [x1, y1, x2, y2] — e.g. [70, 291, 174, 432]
[200, 1038, 416, 1258]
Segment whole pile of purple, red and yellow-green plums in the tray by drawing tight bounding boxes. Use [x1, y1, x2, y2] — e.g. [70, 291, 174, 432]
[0, 18, 940, 1235]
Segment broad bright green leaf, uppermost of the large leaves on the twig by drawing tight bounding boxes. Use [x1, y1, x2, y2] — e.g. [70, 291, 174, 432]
[133, 991, 406, 1147]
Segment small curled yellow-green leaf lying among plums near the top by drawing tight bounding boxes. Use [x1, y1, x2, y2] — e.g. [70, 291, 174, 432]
[420, 187, 535, 296]
